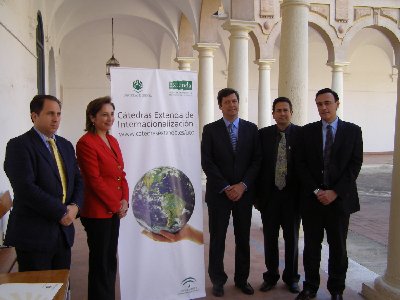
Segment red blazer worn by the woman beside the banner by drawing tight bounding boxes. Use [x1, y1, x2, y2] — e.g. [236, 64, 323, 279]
[76, 132, 129, 219]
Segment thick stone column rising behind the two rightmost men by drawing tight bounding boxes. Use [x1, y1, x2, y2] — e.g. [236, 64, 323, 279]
[278, 0, 309, 125]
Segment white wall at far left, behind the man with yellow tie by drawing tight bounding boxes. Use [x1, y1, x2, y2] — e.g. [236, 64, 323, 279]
[0, 1, 37, 192]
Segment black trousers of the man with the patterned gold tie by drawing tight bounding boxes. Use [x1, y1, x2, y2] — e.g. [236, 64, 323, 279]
[261, 189, 300, 284]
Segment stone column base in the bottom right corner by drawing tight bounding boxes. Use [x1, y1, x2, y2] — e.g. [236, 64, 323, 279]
[361, 276, 400, 300]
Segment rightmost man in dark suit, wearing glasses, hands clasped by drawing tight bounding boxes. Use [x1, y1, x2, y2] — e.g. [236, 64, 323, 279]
[296, 88, 363, 300]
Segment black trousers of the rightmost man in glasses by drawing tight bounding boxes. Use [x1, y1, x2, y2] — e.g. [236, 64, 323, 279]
[302, 204, 350, 294]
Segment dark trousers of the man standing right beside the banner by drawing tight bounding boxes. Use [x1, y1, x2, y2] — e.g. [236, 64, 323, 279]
[207, 197, 252, 285]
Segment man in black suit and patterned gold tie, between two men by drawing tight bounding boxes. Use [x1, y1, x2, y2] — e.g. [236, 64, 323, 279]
[256, 97, 300, 293]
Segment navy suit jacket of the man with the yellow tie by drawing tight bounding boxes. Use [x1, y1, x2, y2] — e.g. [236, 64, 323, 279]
[4, 128, 83, 251]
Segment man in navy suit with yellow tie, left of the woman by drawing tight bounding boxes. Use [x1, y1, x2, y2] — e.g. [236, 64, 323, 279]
[4, 95, 83, 272]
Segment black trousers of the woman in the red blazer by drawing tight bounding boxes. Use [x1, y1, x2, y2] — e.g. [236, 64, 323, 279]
[81, 215, 120, 300]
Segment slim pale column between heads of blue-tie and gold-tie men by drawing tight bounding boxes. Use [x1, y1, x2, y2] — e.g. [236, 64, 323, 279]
[255, 59, 275, 128]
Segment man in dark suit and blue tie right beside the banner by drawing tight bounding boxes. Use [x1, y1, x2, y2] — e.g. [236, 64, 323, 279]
[201, 88, 261, 297]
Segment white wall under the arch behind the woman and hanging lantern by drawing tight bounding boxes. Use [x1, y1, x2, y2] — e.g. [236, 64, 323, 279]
[60, 21, 158, 145]
